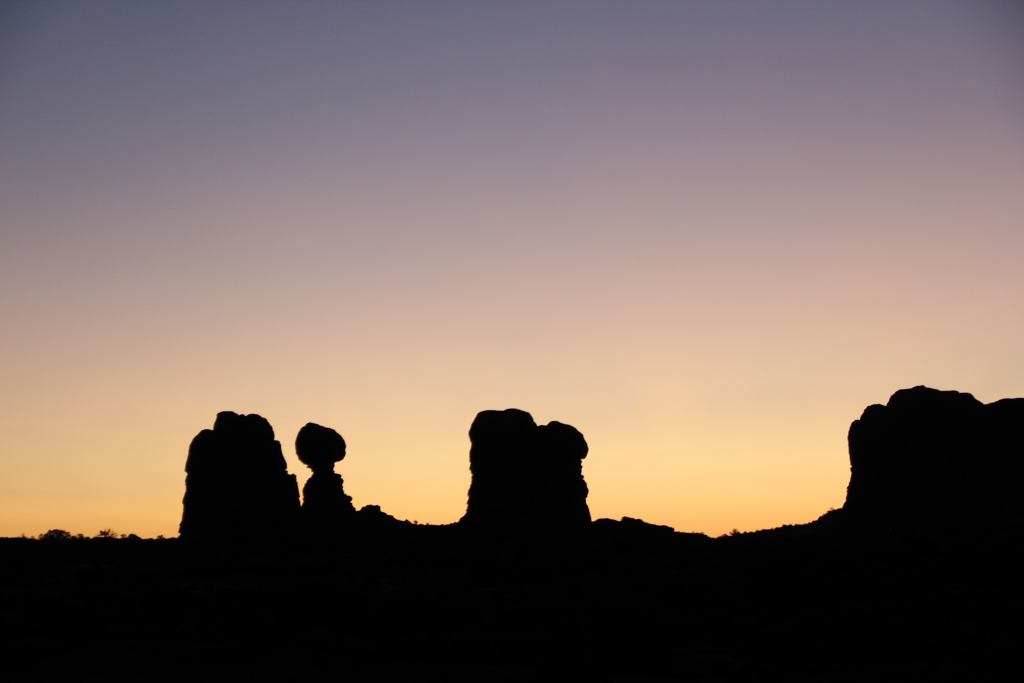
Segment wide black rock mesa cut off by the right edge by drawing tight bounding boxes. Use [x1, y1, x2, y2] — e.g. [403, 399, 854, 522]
[844, 386, 1024, 528]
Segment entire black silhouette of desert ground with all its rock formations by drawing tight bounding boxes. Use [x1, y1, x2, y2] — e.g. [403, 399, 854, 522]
[0, 387, 1024, 681]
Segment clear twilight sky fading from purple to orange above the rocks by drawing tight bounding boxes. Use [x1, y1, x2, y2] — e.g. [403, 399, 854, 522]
[0, 0, 1024, 537]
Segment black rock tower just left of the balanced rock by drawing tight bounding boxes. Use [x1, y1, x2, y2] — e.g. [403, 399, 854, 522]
[178, 412, 299, 540]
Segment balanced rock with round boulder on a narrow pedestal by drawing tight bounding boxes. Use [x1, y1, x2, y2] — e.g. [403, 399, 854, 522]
[295, 422, 355, 528]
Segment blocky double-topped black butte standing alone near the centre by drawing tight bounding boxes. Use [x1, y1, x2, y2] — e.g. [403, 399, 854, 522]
[460, 410, 590, 530]
